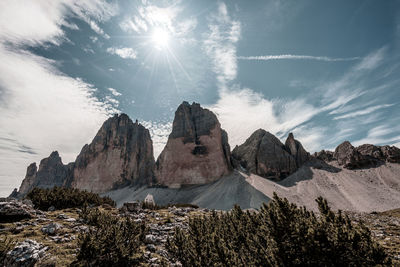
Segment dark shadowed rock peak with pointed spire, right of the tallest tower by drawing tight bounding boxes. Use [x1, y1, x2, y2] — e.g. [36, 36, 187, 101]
[232, 129, 309, 180]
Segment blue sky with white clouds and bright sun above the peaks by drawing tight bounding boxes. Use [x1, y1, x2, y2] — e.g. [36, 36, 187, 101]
[0, 0, 400, 196]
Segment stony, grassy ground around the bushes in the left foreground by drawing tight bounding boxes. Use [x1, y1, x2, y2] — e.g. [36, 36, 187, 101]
[0, 202, 209, 266]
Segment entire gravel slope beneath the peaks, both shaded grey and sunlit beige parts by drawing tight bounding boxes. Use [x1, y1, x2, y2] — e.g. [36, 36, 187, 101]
[104, 161, 400, 212]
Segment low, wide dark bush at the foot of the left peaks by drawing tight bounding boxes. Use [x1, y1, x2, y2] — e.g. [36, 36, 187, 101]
[26, 187, 115, 210]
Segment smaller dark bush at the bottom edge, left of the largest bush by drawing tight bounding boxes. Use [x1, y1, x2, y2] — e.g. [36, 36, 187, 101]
[73, 208, 147, 266]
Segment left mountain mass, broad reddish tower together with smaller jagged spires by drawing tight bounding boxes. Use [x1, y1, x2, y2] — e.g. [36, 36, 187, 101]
[13, 114, 154, 196]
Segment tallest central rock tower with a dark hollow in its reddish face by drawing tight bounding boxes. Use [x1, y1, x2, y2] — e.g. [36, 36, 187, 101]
[155, 102, 232, 187]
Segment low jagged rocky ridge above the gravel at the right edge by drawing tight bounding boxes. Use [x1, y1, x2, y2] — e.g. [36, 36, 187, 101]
[314, 141, 400, 169]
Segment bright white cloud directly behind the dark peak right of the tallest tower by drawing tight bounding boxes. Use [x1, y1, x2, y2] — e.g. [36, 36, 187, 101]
[209, 89, 319, 148]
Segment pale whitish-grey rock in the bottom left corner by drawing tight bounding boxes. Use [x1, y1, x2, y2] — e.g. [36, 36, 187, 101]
[4, 239, 47, 267]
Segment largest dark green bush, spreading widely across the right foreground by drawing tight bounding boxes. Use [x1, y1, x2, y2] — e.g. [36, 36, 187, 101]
[167, 194, 390, 266]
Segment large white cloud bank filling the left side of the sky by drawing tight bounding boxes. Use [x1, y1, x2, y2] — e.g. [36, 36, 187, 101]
[0, 0, 115, 196]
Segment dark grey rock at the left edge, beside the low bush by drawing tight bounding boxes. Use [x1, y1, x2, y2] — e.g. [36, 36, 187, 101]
[0, 199, 36, 223]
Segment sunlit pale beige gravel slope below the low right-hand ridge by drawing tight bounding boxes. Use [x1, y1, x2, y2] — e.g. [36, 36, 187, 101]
[245, 163, 400, 212]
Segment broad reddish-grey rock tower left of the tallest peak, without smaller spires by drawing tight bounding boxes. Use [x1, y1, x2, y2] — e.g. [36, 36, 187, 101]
[71, 114, 154, 193]
